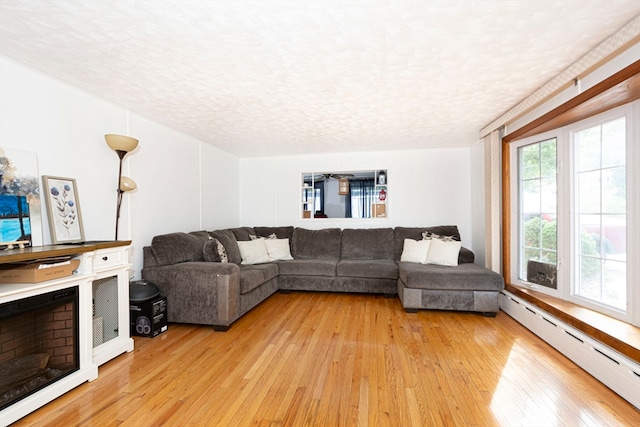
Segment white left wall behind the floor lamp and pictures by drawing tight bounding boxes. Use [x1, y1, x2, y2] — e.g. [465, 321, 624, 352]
[0, 56, 239, 277]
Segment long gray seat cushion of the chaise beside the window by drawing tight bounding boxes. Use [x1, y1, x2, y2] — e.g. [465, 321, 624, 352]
[399, 262, 504, 291]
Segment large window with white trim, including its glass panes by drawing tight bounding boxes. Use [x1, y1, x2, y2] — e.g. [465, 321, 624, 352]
[510, 101, 640, 324]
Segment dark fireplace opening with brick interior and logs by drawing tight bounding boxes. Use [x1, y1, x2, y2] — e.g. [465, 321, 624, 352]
[0, 286, 80, 410]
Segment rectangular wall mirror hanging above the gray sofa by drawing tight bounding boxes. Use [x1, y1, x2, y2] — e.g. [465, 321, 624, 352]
[301, 169, 389, 219]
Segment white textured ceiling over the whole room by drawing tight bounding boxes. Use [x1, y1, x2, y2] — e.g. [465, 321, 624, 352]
[0, 0, 640, 156]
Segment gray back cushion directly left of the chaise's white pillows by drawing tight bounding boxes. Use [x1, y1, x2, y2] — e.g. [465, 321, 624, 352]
[341, 228, 393, 260]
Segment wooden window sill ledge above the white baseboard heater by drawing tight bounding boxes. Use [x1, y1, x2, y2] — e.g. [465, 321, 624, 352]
[505, 283, 640, 363]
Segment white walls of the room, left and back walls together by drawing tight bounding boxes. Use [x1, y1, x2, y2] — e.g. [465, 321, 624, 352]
[0, 56, 484, 278]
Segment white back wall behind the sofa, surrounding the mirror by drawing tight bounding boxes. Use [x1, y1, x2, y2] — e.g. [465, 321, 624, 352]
[240, 148, 484, 248]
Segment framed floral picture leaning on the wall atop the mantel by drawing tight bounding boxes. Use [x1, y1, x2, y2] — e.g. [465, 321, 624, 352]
[42, 175, 84, 245]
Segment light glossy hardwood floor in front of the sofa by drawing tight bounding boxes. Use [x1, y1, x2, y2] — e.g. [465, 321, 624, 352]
[16, 292, 640, 426]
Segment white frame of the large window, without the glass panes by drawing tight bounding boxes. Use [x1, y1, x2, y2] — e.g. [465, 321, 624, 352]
[508, 101, 640, 326]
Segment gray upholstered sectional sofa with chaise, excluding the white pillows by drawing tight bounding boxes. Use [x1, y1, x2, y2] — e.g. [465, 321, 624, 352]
[142, 226, 504, 330]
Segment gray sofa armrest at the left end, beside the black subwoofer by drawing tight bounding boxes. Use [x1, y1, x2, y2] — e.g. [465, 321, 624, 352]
[142, 262, 240, 327]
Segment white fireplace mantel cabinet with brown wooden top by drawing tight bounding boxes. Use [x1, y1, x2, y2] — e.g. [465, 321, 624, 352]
[0, 241, 133, 426]
